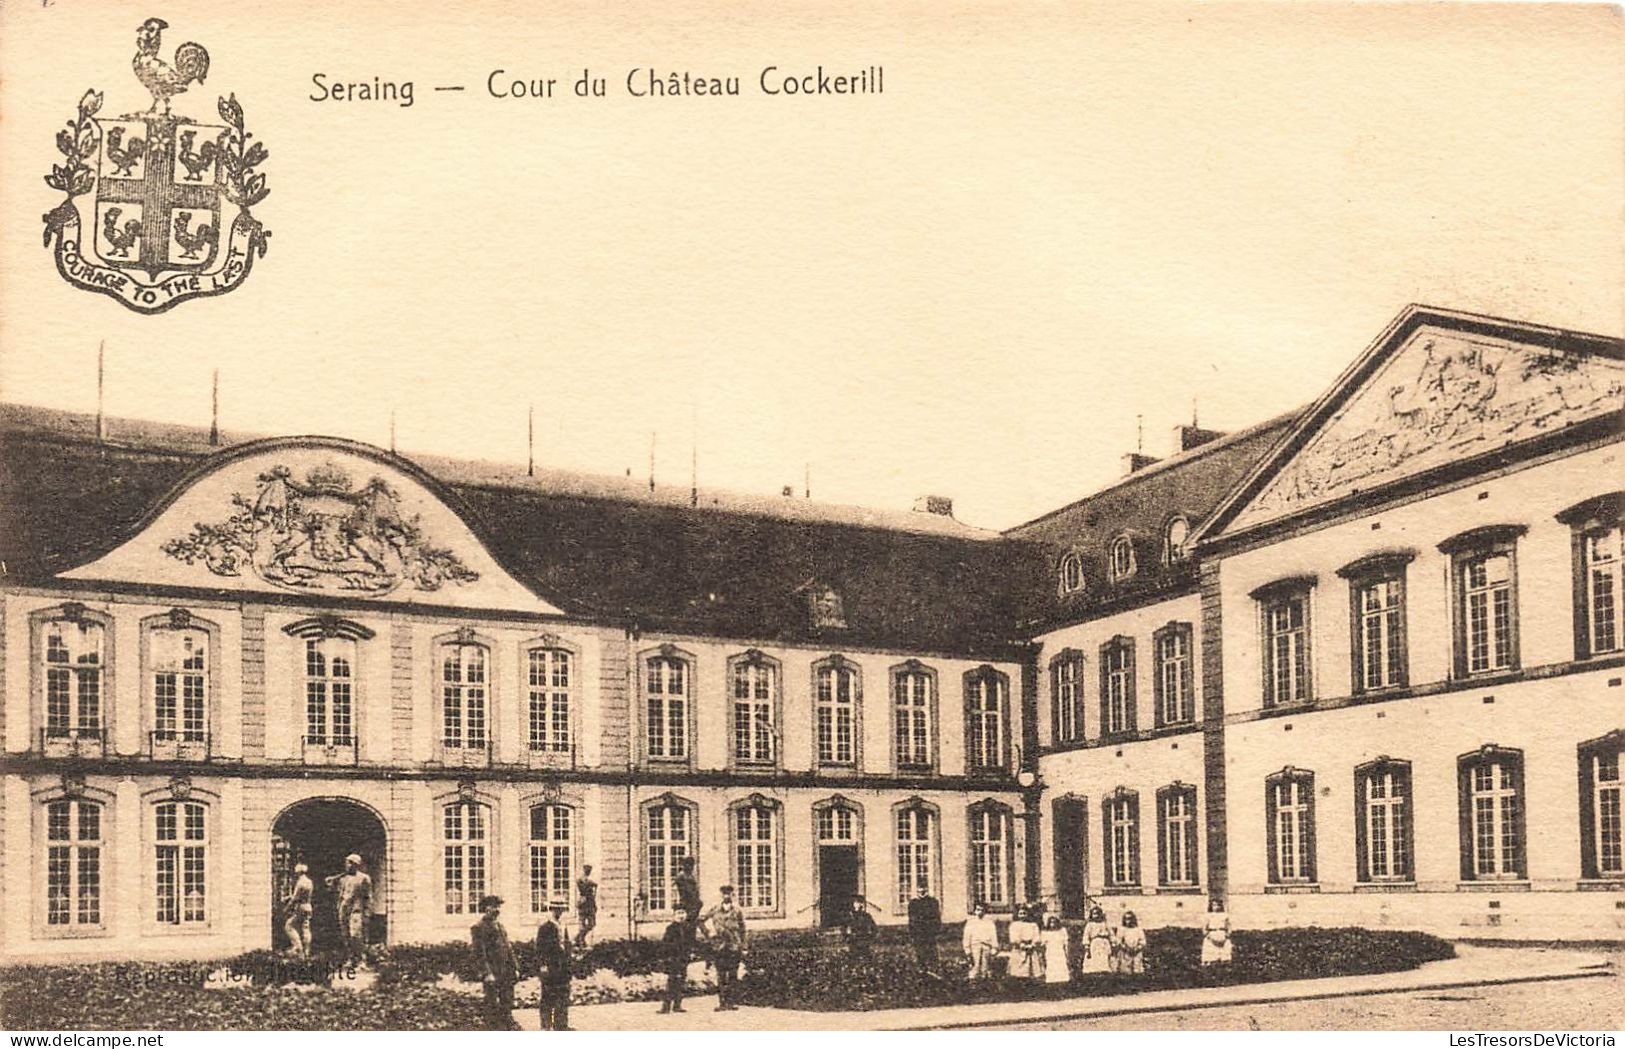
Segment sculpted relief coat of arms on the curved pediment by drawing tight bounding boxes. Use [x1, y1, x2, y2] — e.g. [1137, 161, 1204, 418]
[164, 463, 479, 596]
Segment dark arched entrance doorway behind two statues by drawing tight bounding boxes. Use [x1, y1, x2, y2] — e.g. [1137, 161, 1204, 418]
[271, 797, 388, 950]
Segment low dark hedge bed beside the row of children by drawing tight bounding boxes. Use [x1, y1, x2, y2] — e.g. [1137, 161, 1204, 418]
[741, 927, 1456, 1010]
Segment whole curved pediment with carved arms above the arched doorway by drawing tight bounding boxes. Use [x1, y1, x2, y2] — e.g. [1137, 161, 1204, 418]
[63, 438, 559, 612]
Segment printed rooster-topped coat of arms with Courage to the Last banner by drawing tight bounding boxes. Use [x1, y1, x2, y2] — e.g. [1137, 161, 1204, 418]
[44, 18, 271, 313]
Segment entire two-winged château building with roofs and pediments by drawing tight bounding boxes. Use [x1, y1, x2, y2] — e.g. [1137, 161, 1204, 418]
[0, 307, 1625, 960]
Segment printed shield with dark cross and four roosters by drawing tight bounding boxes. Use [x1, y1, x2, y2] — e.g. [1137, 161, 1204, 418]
[94, 115, 228, 276]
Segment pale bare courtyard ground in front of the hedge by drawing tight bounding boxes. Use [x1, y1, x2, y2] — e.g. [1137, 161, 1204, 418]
[539, 945, 1625, 1031]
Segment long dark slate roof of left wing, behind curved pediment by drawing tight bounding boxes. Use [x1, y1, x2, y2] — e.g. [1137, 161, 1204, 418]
[0, 406, 1045, 654]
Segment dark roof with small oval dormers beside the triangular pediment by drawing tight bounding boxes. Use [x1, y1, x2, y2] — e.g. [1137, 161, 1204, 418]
[1004, 411, 1300, 628]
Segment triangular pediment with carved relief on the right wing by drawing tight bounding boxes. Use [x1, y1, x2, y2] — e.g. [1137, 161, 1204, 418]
[1204, 309, 1625, 537]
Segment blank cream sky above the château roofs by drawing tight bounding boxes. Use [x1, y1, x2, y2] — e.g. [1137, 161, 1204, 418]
[0, 0, 1625, 526]
